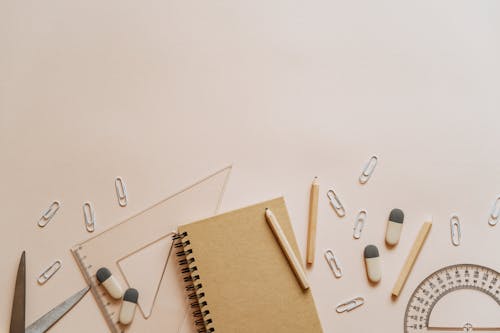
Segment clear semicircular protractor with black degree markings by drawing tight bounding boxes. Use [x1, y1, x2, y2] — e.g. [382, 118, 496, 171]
[404, 264, 500, 333]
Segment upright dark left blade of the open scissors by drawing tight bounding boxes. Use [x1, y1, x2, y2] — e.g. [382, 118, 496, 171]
[9, 251, 26, 333]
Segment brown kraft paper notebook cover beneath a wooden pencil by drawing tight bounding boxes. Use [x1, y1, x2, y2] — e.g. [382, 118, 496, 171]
[177, 198, 323, 333]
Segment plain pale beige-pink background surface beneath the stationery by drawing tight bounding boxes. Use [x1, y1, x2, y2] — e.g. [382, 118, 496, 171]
[0, 0, 500, 332]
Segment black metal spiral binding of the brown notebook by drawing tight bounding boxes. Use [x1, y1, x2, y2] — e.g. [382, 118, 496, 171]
[173, 232, 215, 333]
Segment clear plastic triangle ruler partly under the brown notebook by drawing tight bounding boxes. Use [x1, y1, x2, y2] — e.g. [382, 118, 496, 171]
[72, 167, 231, 333]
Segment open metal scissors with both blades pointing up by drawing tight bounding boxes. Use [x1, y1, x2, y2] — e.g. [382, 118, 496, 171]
[9, 251, 90, 333]
